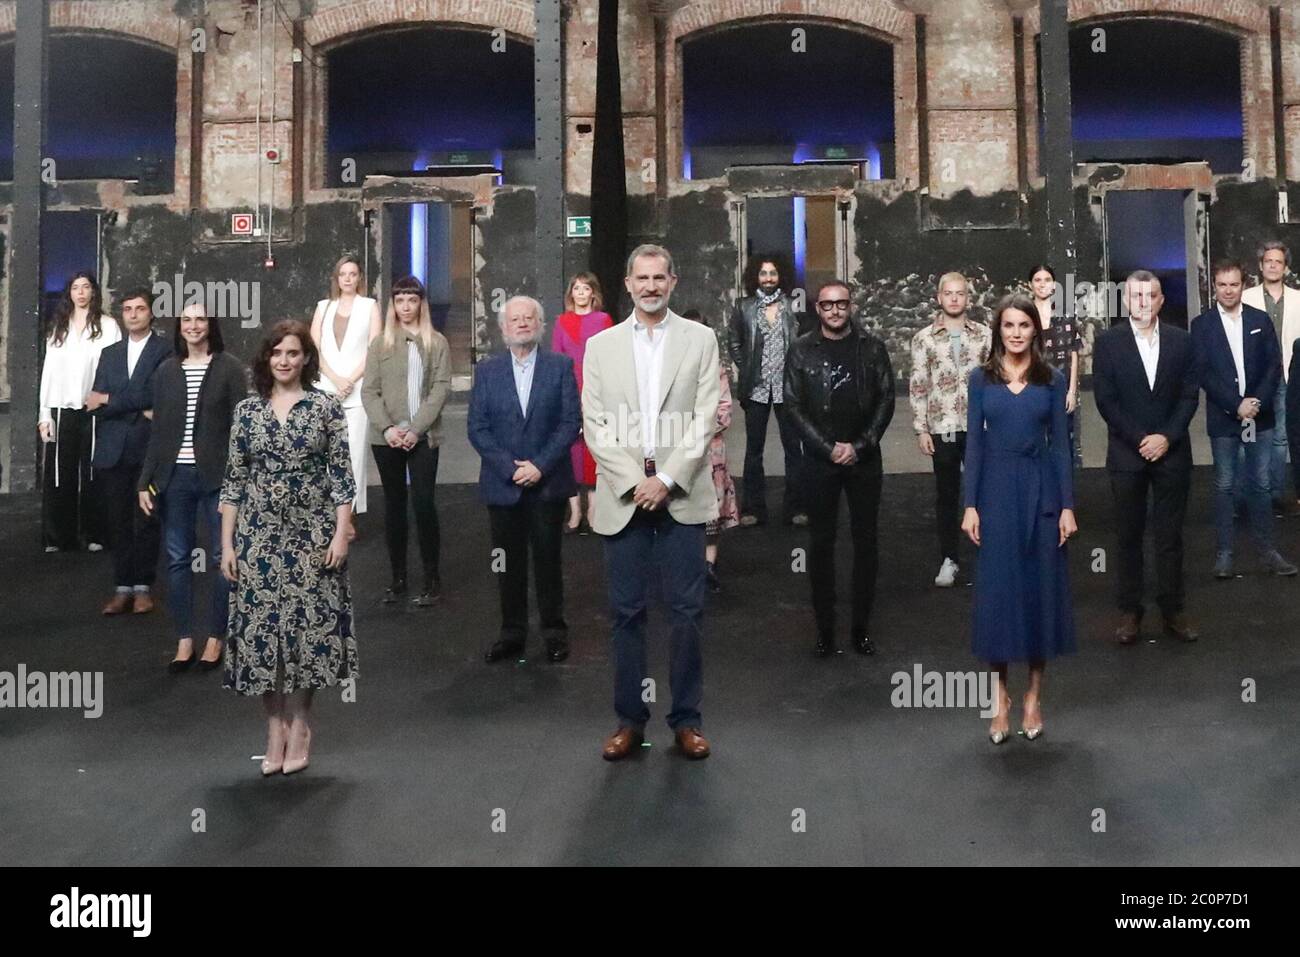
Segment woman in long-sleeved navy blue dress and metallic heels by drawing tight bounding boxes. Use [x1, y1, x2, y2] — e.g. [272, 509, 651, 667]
[962, 294, 1079, 744]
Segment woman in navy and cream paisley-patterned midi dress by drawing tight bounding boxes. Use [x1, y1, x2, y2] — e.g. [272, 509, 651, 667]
[221, 320, 358, 775]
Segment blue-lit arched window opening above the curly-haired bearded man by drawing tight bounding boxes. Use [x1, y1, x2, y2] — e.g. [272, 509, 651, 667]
[681, 22, 894, 179]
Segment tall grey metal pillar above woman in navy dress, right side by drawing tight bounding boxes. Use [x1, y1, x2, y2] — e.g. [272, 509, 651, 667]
[1039, 0, 1078, 281]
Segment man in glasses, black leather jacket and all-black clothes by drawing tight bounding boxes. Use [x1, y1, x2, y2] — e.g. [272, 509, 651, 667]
[785, 281, 894, 657]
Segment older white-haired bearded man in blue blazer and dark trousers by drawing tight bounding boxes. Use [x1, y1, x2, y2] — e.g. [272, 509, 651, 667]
[468, 296, 581, 663]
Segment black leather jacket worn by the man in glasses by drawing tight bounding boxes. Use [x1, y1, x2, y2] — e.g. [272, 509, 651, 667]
[785, 326, 894, 469]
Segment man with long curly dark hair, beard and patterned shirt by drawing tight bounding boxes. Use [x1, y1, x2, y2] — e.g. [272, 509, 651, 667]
[727, 254, 807, 525]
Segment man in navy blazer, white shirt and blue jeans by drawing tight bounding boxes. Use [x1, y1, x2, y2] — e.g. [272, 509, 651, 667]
[1191, 260, 1296, 579]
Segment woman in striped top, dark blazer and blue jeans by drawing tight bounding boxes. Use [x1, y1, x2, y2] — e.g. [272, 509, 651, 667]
[138, 303, 248, 672]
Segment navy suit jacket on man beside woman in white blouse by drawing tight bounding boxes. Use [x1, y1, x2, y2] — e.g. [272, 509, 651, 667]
[91, 333, 172, 468]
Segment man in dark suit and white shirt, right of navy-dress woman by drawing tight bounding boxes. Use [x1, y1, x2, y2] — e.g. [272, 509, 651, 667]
[1092, 269, 1200, 645]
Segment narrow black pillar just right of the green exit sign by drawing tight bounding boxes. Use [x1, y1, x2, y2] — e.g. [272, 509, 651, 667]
[590, 0, 629, 320]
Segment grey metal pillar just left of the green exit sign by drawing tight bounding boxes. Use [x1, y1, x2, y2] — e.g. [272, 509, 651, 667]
[533, 0, 564, 317]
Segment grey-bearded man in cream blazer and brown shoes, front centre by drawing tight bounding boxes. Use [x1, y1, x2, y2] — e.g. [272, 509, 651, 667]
[582, 244, 719, 761]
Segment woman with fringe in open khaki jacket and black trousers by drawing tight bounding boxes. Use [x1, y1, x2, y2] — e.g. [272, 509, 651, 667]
[361, 276, 451, 607]
